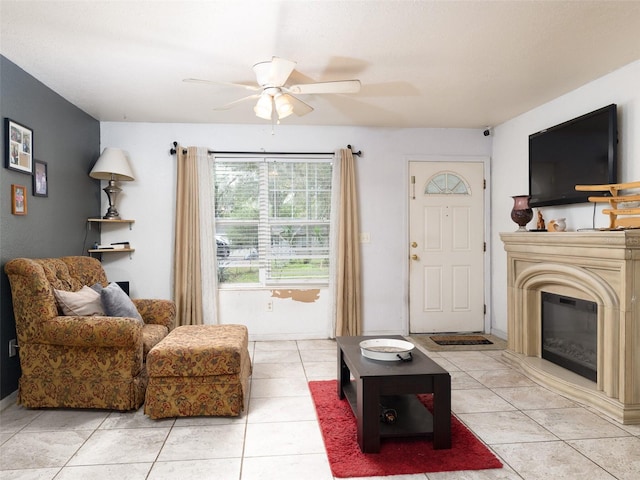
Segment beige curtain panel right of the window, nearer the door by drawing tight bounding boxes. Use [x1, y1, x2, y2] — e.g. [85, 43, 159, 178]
[335, 148, 362, 336]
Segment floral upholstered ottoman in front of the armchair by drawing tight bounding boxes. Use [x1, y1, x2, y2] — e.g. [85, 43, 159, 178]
[144, 325, 251, 419]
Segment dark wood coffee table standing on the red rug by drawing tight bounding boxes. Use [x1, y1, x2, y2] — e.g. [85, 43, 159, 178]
[336, 335, 451, 453]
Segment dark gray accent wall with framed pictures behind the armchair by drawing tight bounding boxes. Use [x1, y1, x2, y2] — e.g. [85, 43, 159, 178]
[0, 56, 104, 399]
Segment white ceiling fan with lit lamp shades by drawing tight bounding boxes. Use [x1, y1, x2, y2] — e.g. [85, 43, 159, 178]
[184, 57, 360, 120]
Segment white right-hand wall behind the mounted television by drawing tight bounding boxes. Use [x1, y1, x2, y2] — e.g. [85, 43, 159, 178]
[491, 61, 640, 336]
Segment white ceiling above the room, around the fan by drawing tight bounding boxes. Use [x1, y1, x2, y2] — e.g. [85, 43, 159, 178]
[0, 0, 640, 128]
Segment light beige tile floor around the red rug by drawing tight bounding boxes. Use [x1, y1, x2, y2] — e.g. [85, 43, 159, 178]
[0, 340, 640, 480]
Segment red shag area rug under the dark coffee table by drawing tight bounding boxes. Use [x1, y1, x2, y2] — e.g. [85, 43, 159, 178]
[309, 380, 502, 478]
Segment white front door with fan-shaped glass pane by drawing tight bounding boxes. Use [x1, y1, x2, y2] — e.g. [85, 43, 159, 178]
[409, 162, 484, 333]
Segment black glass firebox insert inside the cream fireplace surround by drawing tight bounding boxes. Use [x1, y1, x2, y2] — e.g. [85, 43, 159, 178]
[540, 292, 598, 382]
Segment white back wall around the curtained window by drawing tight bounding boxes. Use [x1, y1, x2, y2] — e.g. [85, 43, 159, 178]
[101, 121, 491, 339]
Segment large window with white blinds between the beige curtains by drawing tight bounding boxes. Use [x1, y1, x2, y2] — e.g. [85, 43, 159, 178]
[213, 157, 332, 286]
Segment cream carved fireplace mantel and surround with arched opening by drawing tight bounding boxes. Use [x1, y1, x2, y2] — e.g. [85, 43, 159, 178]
[500, 230, 640, 424]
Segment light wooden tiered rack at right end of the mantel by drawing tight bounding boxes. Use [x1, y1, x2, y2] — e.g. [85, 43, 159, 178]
[575, 182, 640, 229]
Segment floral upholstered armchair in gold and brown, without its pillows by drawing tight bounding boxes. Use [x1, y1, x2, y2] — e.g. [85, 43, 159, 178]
[5, 256, 176, 411]
